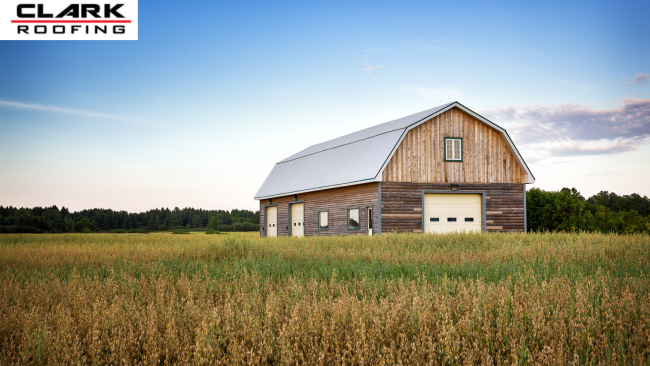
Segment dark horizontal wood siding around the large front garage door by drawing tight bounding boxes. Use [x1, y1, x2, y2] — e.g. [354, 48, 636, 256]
[381, 182, 524, 234]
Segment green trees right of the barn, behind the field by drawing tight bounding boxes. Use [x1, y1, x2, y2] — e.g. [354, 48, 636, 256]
[526, 188, 650, 234]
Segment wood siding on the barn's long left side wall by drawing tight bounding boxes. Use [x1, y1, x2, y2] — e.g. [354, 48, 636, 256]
[260, 183, 379, 237]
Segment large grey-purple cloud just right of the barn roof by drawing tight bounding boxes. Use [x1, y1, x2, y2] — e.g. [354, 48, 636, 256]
[480, 99, 650, 159]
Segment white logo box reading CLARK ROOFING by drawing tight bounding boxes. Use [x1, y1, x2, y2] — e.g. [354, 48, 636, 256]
[0, 0, 138, 41]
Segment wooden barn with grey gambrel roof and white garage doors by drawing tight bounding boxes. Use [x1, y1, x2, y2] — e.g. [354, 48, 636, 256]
[255, 102, 535, 237]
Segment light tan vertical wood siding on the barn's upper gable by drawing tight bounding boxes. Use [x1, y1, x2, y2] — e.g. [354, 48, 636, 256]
[382, 108, 526, 183]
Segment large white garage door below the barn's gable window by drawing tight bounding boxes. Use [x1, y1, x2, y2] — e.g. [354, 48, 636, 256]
[424, 193, 483, 233]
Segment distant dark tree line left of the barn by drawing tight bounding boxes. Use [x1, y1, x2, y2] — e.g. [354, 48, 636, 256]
[0, 206, 260, 233]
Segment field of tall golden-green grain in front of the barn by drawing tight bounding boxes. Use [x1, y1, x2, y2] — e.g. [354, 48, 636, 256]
[0, 233, 650, 365]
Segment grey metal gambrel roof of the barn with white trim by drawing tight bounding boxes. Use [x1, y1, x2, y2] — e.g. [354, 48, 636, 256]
[255, 102, 535, 200]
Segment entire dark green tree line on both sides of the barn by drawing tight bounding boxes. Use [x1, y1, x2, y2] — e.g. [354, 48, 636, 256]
[0, 188, 650, 234]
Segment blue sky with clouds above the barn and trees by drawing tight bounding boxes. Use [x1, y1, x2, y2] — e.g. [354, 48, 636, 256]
[0, 0, 650, 211]
